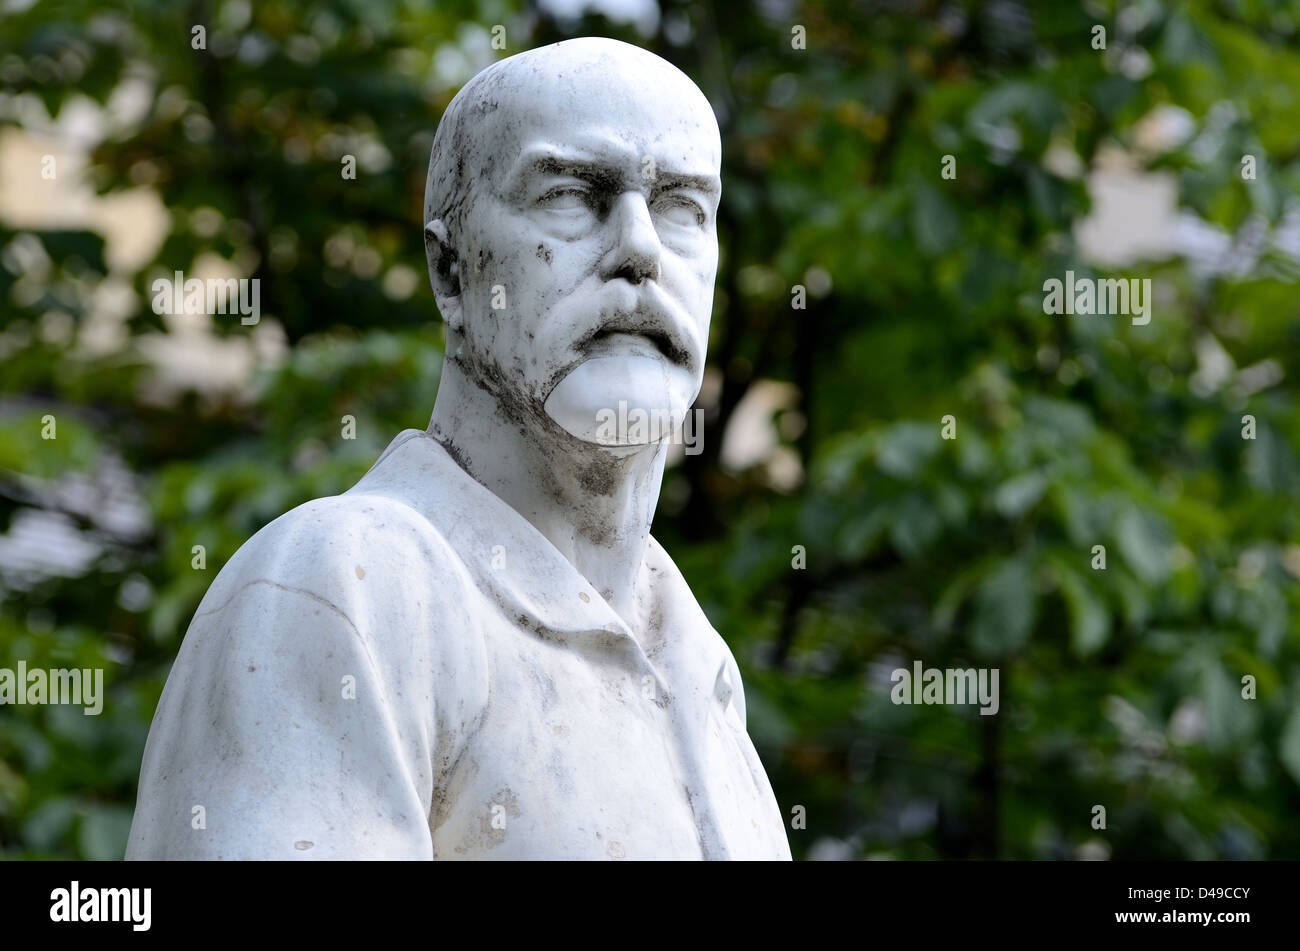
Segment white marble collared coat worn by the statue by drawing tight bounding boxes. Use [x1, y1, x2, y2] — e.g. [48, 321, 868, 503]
[126, 430, 790, 859]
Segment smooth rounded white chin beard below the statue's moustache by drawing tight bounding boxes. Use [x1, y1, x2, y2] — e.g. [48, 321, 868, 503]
[546, 355, 692, 447]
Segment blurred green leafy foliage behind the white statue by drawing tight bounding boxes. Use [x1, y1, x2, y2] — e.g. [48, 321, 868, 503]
[0, 0, 1300, 859]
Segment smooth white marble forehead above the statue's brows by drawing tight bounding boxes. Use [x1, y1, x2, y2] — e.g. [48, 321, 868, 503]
[463, 38, 722, 173]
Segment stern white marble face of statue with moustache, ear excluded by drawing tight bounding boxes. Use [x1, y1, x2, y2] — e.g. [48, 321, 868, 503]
[434, 40, 722, 444]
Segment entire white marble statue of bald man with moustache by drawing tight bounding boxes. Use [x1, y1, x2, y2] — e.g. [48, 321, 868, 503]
[126, 38, 790, 859]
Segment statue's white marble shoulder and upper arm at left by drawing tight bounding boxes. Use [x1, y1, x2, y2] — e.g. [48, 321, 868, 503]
[127, 492, 488, 859]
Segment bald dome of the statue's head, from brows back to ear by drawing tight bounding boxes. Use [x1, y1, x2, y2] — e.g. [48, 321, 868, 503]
[424, 36, 722, 271]
